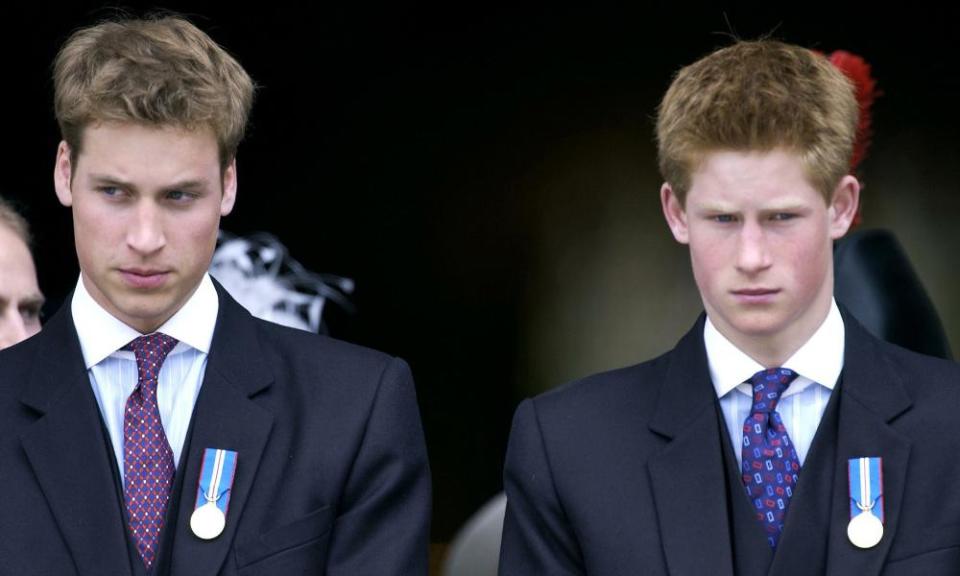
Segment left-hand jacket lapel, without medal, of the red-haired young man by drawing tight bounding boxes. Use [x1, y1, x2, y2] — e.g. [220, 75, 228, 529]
[648, 316, 733, 576]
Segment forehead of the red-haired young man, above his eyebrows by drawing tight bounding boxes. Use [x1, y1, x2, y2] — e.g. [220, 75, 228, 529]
[687, 149, 823, 205]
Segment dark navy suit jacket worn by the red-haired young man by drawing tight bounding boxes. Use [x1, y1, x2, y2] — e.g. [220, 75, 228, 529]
[500, 314, 960, 576]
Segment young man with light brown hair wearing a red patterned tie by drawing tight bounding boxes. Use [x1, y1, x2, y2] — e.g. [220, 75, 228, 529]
[0, 16, 430, 576]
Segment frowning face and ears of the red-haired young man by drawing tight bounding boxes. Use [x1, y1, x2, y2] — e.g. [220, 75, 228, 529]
[661, 150, 859, 364]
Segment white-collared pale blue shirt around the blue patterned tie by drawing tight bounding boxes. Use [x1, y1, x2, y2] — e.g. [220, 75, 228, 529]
[703, 300, 844, 466]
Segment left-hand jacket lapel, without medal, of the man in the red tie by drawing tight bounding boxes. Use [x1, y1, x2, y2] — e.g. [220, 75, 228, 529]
[20, 300, 130, 575]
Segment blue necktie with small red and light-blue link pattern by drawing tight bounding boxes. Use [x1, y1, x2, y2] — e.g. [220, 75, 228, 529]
[741, 368, 800, 549]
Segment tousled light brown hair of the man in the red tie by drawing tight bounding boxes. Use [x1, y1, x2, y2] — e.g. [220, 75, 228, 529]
[53, 16, 254, 168]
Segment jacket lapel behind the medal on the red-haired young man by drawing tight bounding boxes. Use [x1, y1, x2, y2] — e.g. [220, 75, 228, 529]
[827, 314, 911, 576]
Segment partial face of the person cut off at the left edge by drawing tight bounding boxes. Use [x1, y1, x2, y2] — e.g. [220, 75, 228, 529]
[0, 224, 43, 349]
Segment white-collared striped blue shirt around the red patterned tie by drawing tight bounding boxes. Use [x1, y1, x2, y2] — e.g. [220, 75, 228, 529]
[71, 274, 220, 481]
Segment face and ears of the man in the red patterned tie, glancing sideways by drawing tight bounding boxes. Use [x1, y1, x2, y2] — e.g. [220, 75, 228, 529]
[54, 123, 236, 333]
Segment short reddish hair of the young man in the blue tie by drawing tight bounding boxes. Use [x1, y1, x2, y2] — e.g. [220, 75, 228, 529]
[657, 40, 858, 202]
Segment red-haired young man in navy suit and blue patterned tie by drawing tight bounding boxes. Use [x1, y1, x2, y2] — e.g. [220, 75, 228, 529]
[500, 41, 960, 576]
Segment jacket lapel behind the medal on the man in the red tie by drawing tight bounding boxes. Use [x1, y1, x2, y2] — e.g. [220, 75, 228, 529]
[170, 285, 273, 575]
